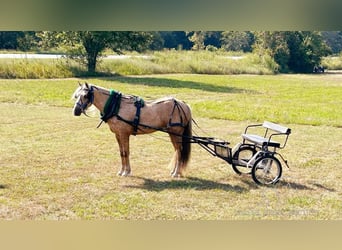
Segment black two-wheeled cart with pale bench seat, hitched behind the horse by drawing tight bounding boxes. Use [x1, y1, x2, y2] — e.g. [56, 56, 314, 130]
[189, 121, 291, 185]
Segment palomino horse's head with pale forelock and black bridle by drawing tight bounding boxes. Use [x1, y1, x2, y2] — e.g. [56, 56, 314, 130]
[72, 83, 94, 116]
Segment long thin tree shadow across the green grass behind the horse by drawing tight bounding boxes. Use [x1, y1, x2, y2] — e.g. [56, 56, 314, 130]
[97, 76, 255, 94]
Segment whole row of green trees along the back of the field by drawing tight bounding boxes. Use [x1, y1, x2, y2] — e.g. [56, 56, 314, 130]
[0, 31, 342, 74]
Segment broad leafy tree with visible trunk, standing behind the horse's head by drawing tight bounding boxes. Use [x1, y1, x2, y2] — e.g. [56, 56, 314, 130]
[38, 31, 153, 74]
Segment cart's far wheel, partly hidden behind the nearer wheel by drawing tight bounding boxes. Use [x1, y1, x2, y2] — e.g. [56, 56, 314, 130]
[232, 145, 257, 175]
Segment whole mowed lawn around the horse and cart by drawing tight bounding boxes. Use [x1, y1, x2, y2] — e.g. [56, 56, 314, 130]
[0, 74, 342, 220]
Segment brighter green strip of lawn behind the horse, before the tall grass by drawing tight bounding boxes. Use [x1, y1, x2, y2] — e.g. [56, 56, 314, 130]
[0, 74, 342, 127]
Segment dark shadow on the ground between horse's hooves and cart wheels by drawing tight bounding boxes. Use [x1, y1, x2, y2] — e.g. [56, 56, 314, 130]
[127, 177, 248, 193]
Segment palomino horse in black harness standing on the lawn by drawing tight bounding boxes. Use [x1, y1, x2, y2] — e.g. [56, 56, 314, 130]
[73, 83, 192, 177]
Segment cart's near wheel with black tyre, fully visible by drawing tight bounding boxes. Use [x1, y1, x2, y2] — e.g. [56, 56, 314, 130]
[252, 156, 282, 185]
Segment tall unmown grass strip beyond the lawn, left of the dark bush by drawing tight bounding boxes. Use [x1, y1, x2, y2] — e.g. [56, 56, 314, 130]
[0, 51, 276, 79]
